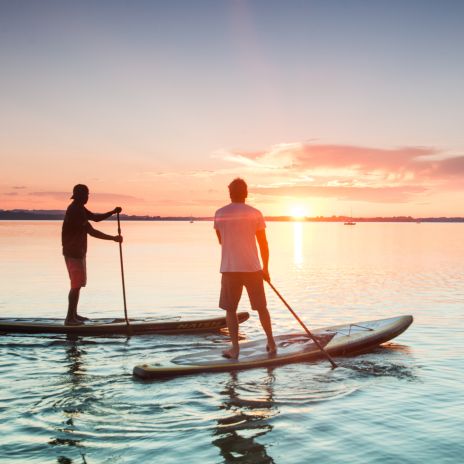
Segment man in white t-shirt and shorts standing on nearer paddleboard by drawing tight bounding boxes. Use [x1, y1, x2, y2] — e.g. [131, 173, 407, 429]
[214, 178, 276, 359]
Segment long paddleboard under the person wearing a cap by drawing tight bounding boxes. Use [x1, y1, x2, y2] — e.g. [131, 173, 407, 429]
[0, 311, 250, 336]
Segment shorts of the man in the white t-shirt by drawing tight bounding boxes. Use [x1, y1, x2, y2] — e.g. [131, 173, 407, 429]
[219, 271, 267, 312]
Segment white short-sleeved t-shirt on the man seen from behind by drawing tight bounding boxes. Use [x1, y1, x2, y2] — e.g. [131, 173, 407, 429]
[214, 203, 266, 272]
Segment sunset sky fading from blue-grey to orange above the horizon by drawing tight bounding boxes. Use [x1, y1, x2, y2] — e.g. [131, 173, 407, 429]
[0, 0, 464, 216]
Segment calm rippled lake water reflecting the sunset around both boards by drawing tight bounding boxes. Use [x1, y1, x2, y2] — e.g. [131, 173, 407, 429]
[0, 221, 464, 464]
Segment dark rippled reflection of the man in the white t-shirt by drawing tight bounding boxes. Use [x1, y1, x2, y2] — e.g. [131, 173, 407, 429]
[212, 370, 276, 464]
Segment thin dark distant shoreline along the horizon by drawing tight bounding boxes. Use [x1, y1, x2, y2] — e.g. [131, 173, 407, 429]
[0, 210, 464, 223]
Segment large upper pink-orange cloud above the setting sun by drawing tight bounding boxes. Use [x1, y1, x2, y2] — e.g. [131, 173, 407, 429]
[216, 143, 464, 187]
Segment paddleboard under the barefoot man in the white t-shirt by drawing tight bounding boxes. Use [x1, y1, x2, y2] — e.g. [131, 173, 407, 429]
[133, 316, 413, 379]
